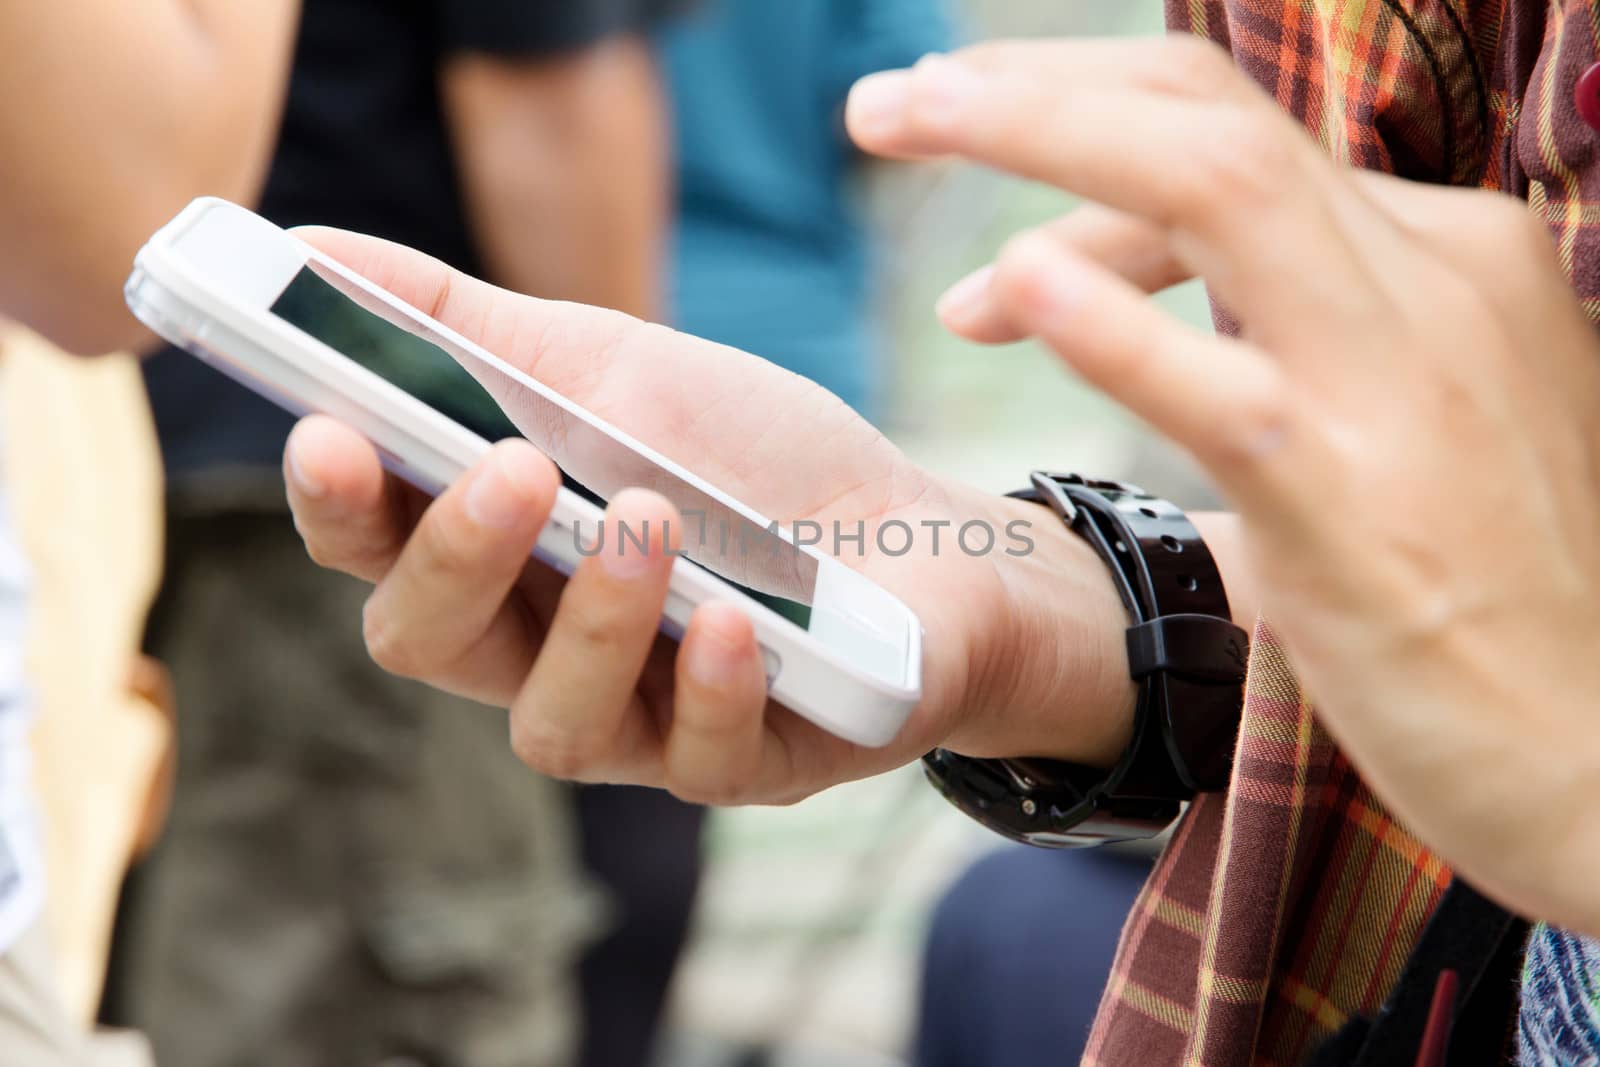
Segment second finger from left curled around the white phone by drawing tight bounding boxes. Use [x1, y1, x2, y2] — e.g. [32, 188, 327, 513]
[365, 440, 560, 704]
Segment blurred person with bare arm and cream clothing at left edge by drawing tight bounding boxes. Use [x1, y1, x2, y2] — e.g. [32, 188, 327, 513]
[0, 0, 298, 1067]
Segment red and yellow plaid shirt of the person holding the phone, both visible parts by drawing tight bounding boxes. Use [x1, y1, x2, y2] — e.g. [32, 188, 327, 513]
[1085, 0, 1600, 1067]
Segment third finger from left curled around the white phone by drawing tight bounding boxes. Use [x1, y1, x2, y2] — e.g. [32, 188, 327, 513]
[510, 490, 682, 782]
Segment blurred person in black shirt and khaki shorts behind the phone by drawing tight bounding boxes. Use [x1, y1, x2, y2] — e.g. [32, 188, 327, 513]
[106, 0, 699, 1067]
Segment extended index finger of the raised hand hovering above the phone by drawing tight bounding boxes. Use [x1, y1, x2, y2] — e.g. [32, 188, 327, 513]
[846, 38, 1394, 333]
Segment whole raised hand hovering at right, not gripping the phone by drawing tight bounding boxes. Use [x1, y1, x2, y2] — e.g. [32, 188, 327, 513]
[848, 38, 1600, 934]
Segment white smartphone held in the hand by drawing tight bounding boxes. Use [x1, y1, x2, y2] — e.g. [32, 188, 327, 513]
[126, 198, 922, 745]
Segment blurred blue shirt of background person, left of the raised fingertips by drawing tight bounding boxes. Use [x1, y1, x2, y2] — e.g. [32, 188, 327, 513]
[662, 0, 950, 414]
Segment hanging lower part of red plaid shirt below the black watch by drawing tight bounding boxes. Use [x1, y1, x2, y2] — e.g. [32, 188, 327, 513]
[1085, 624, 1450, 1067]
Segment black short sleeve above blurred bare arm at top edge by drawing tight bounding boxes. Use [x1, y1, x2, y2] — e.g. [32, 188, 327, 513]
[437, 0, 693, 56]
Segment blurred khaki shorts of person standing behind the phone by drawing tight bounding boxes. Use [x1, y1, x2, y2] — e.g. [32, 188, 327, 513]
[104, 505, 605, 1067]
